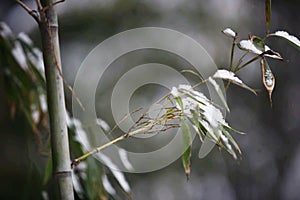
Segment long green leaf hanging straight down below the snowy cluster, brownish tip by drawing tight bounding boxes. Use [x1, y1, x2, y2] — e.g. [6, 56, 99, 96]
[180, 119, 192, 178]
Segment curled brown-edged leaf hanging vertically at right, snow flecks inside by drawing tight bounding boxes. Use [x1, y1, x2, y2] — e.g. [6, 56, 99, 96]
[260, 58, 275, 105]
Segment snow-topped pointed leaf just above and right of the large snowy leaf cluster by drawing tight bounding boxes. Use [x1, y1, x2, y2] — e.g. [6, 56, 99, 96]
[212, 69, 256, 95]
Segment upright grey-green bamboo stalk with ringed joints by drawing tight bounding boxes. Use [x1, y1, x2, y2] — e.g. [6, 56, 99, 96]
[37, 0, 74, 200]
